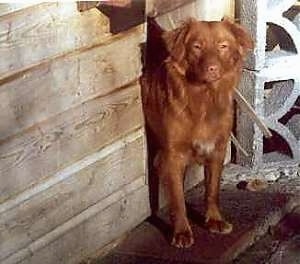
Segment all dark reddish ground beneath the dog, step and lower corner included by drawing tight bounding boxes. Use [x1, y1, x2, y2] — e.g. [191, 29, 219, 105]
[81, 175, 300, 264]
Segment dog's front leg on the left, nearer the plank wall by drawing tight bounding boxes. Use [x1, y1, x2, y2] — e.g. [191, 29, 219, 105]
[158, 150, 194, 248]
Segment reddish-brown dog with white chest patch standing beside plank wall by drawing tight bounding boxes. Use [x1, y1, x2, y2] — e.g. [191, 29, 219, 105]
[142, 19, 253, 247]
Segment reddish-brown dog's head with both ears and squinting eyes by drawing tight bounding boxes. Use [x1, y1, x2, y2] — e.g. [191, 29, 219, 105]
[163, 19, 253, 83]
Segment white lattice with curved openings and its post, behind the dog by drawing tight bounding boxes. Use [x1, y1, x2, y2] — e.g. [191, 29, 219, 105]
[237, 0, 300, 169]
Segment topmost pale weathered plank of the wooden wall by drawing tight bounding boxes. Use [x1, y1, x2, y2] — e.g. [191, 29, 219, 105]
[0, 2, 110, 78]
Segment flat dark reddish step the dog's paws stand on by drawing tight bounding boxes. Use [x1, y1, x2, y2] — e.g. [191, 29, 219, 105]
[83, 177, 300, 264]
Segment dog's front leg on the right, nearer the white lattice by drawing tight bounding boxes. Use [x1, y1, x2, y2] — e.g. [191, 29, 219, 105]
[204, 153, 232, 234]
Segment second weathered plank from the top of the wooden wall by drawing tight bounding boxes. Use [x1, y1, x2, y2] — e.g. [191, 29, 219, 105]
[0, 28, 142, 140]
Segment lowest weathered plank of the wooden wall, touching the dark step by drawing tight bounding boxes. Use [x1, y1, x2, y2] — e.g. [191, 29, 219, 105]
[1, 182, 149, 264]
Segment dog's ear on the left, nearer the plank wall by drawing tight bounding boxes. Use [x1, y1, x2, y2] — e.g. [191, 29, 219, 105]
[162, 18, 196, 66]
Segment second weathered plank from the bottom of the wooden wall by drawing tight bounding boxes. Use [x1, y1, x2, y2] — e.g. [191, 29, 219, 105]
[0, 133, 146, 261]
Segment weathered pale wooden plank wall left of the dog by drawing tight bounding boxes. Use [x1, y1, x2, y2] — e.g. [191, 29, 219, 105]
[0, 2, 149, 264]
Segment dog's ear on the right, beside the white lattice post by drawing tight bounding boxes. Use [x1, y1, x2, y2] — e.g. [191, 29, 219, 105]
[222, 17, 254, 57]
